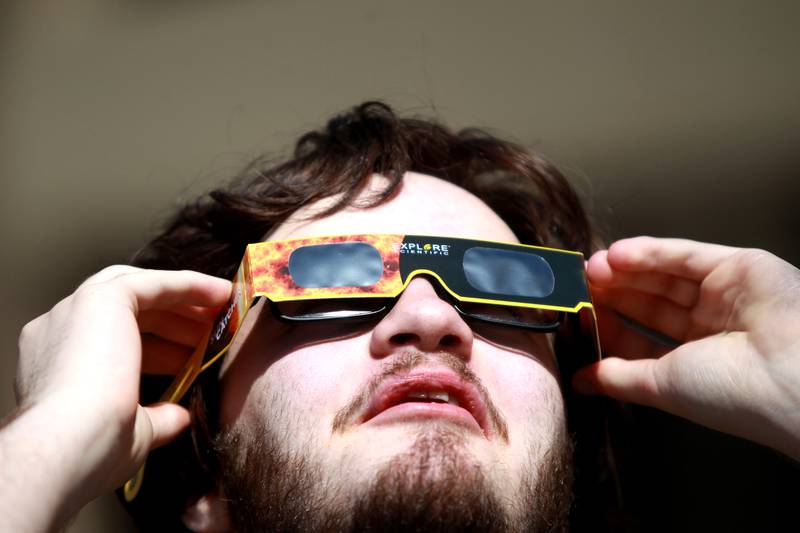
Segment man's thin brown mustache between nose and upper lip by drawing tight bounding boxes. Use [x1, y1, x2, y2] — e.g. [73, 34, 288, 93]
[332, 352, 508, 442]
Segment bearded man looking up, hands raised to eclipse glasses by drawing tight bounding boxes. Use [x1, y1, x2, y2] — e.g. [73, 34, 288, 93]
[0, 104, 800, 531]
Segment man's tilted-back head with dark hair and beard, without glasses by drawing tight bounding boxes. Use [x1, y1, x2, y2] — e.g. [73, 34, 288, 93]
[123, 104, 591, 530]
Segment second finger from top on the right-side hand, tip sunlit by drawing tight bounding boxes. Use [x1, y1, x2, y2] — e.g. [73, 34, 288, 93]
[586, 250, 700, 307]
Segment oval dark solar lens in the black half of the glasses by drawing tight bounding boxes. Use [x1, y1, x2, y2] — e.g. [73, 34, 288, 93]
[463, 247, 555, 298]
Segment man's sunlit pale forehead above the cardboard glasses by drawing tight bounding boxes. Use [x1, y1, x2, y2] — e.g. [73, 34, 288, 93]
[268, 172, 517, 242]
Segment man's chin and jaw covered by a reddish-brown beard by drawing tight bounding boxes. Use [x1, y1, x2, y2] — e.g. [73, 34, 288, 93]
[218, 410, 571, 533]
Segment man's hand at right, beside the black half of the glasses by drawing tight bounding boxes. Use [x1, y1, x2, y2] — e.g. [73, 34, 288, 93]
[574, 237, 800, 460]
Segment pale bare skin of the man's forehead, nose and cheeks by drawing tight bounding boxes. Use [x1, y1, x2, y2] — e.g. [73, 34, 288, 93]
[184, 173, 565, 531]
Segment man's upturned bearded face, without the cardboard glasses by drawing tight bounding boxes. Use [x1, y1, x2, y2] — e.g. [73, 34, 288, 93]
[191, 174, 571, 530]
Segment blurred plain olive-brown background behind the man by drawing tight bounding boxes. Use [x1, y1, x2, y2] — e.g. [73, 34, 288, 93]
[0, 0, 800, 531]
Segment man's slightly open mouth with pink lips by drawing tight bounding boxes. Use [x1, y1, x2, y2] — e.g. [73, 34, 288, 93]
[359, 368, 494, 438]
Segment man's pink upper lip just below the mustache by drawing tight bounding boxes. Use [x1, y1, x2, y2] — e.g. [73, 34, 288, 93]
[359, 369, 492, 436]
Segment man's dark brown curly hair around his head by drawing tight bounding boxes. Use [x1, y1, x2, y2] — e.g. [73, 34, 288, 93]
[120, 102, 613, 531]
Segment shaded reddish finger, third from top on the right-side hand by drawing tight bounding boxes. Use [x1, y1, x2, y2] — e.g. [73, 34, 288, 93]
[592, 289, 694, 341]
